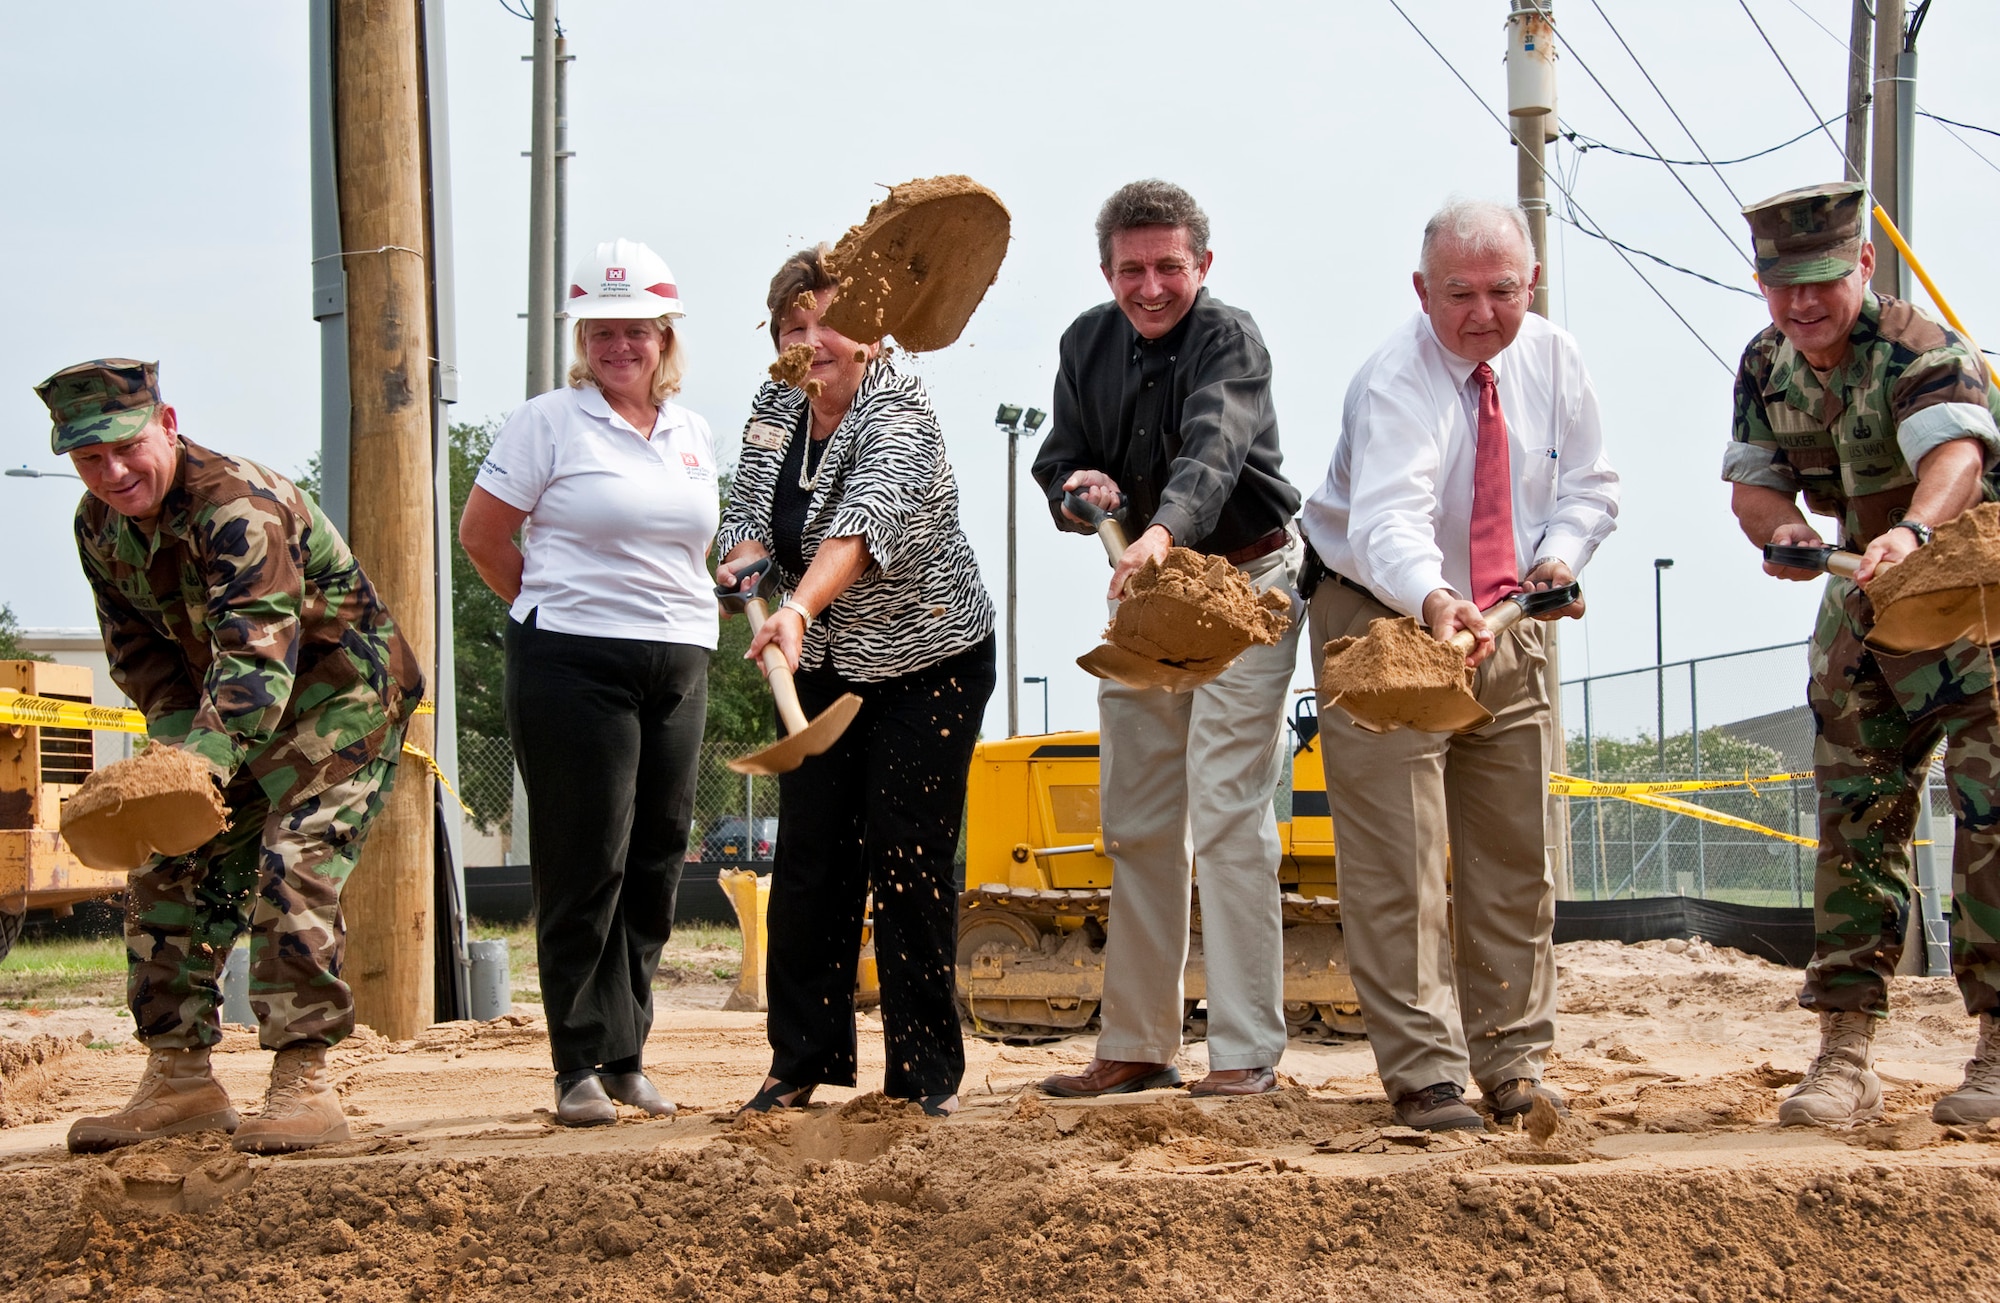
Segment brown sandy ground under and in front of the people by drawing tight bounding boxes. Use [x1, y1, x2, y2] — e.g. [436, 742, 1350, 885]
[0, 941, 2000, 1303]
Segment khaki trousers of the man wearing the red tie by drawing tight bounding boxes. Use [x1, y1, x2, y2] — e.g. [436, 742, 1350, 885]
[1312, 580, 1556, 1101]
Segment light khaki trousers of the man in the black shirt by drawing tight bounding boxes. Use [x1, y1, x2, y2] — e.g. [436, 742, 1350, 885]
[1096, 538, 1304, 1069]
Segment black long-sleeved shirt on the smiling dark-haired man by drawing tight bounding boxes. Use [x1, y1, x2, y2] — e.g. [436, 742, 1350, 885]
[1034, 290, 1298, 556]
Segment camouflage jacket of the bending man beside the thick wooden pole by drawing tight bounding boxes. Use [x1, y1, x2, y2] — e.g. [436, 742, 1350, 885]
[76, 440, 424, 809]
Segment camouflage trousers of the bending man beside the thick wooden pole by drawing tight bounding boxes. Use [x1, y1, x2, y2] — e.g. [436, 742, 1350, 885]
[126, 747, 402, 1049]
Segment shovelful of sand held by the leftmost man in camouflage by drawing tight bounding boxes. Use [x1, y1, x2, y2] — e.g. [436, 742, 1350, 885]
[62, 743, 230, 869]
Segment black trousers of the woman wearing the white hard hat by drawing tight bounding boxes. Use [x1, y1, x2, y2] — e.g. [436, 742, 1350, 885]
[506, 612, 708, 1073]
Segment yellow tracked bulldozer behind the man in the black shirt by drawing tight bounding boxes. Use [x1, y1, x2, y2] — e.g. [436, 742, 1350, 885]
[958, 693, 1362, 1037]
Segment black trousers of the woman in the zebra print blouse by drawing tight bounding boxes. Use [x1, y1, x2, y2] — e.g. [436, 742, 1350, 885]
[764, 636, 994, 1099]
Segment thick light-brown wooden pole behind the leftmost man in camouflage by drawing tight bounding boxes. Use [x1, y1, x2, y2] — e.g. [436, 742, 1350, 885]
[334, 0, 438, 1039]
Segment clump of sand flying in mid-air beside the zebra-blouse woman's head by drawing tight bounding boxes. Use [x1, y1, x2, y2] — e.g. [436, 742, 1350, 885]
[824, 176, 1010, 354]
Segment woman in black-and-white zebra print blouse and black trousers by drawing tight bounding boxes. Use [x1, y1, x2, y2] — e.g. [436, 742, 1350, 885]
[716, 246, 994, 1115]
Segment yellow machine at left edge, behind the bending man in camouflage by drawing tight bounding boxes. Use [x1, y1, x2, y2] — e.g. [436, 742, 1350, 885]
[0, 661, 126, 959]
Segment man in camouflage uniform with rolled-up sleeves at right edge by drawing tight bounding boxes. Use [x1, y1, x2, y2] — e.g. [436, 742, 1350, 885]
[1722, 182, 2000, 1125]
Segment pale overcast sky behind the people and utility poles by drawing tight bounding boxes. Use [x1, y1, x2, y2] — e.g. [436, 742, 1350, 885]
[0, 0, 2000, 735]
